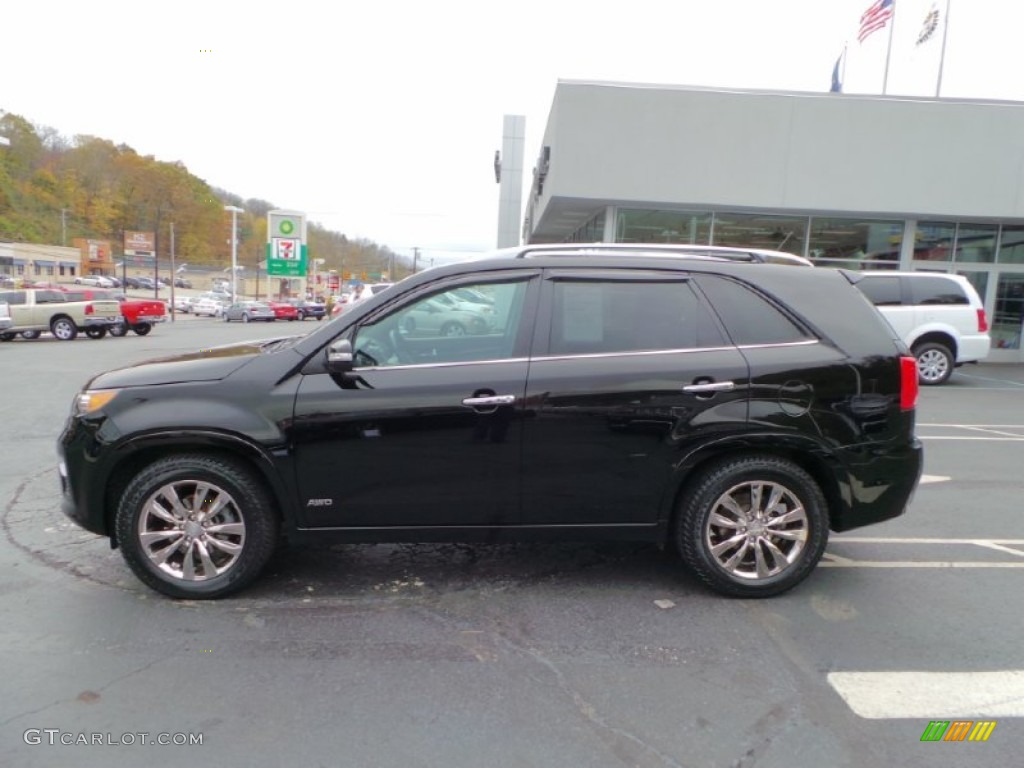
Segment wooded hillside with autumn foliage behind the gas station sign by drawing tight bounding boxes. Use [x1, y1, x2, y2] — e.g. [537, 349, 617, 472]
[0, 113, 409, 276]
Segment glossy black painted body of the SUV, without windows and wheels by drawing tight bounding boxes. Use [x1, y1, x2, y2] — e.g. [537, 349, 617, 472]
[59, 257, 922, 541]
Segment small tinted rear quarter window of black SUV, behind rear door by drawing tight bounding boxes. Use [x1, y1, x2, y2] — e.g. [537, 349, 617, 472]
[697, 275, 813, 345]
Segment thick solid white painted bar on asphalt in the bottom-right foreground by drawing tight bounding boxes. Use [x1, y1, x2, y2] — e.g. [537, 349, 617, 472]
[828, 670, 1024, 720]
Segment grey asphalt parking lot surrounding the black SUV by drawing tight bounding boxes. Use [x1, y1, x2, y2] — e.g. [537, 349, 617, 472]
[0, 325, 1024, 768]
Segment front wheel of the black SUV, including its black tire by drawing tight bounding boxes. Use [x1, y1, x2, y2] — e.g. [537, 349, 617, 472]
[115, 454, 279, 600]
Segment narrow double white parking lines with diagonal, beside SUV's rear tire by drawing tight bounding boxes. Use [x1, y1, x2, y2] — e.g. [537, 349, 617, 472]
[818, 536, 1024, 568]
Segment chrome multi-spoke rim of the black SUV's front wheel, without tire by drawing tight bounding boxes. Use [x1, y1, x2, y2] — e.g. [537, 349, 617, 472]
[137, 480, 246, 582]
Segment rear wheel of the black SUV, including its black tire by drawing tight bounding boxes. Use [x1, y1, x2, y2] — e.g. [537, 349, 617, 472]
[675, 455, 828, 597]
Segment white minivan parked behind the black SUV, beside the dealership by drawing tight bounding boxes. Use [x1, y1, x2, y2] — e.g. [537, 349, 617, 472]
[853, 269, 991, 385]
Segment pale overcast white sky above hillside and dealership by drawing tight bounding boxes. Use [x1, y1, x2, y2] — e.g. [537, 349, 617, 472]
[0, 0, 1024, 263]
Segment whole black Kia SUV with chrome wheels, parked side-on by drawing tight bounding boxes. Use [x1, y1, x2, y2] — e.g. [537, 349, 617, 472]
[59, 246, 922, 598]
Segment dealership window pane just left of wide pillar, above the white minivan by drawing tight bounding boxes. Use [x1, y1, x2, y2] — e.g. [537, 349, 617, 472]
[808, 216, 903, 269]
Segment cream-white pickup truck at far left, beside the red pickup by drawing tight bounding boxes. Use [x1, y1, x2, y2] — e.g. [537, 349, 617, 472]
[0, 288, 122, 341]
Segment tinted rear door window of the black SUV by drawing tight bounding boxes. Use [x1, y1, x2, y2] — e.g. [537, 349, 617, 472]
[550, 281, 726, 354]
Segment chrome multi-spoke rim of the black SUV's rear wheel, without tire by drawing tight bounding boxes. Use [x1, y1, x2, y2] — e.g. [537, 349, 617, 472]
[703, 481, 809, 580]
